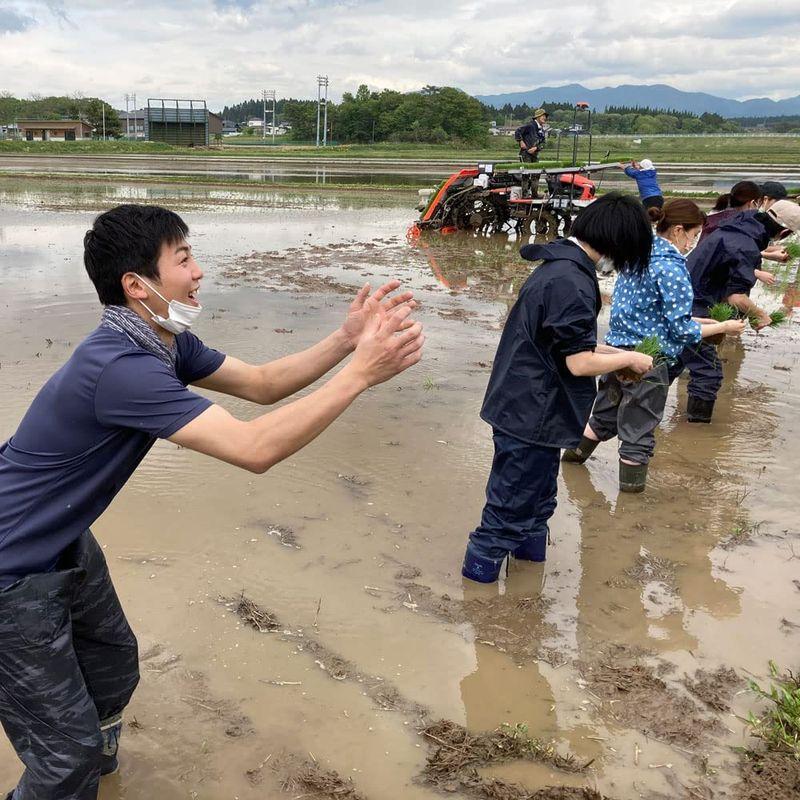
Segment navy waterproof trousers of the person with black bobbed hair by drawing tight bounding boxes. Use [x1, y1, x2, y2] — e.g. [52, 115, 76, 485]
[469, 430, 561, 559]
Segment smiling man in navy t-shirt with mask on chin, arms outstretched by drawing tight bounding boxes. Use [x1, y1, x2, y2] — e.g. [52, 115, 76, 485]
[0, 205, 424, 800]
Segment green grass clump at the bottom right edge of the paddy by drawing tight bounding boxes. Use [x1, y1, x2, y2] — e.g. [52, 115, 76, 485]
[747, 661, 800, 761]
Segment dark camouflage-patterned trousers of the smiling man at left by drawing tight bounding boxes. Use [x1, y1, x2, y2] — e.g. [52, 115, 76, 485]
[0, 531, 139, 800]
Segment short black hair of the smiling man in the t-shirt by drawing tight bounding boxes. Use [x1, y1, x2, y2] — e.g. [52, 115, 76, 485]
[83, 205, 189, 306]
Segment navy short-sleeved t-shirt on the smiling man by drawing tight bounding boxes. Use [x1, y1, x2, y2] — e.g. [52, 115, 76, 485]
[0, 327, 225, 588]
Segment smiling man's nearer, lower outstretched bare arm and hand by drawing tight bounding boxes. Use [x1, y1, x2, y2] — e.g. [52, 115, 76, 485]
[169, 299, 425, 473]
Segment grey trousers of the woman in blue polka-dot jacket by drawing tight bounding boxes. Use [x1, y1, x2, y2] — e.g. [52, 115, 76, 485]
[589, 364, 669, 464]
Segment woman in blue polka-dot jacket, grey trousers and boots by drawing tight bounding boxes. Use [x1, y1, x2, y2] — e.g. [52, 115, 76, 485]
[561, 199, 745, 492]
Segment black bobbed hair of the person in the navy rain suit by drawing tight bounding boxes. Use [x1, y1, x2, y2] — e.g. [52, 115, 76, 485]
[570, 192, 653, 274]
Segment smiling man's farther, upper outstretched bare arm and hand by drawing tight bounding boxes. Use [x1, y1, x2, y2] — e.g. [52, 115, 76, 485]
[195, 280, 413, 405]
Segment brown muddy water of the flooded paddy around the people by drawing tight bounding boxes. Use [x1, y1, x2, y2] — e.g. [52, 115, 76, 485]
[0, 181, 800, 800]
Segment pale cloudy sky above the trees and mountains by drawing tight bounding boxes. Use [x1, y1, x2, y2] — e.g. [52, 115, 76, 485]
[0, 0, 800, 109]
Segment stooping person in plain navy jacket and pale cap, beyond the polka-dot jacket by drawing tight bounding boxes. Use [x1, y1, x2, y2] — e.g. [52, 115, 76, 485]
[669, 200, 800, 422]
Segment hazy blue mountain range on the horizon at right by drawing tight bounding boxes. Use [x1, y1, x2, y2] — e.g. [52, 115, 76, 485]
[477, 83, 800, 117]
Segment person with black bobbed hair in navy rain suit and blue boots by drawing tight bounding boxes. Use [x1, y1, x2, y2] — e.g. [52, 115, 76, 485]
[461, 192, 653, 583]
